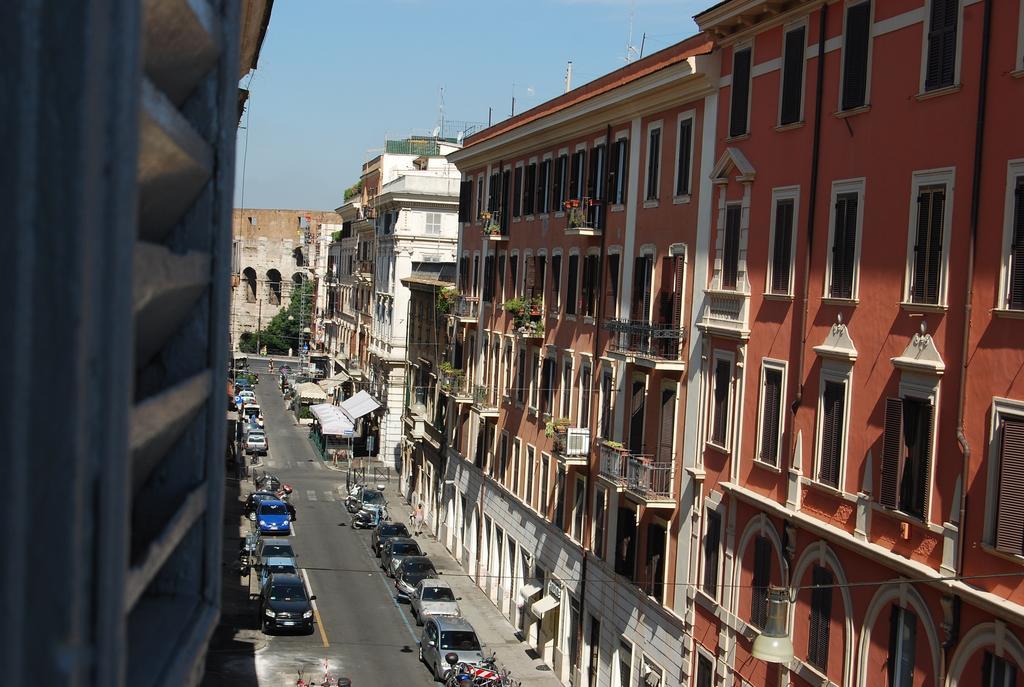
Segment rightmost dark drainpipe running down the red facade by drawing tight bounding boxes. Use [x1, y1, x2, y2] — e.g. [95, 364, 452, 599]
[956, 0, 992, 574]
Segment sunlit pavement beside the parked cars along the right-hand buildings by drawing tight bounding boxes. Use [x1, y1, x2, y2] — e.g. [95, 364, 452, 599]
[417, 533, 562, 687]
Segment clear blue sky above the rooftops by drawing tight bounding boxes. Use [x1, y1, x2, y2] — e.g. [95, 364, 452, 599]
[234, 0, 715, 210]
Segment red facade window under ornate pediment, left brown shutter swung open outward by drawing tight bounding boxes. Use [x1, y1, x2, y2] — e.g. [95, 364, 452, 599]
[879, 397, 933, 519]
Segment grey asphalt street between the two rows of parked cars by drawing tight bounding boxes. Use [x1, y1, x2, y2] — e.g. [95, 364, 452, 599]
[253, 376, 435, 687]
